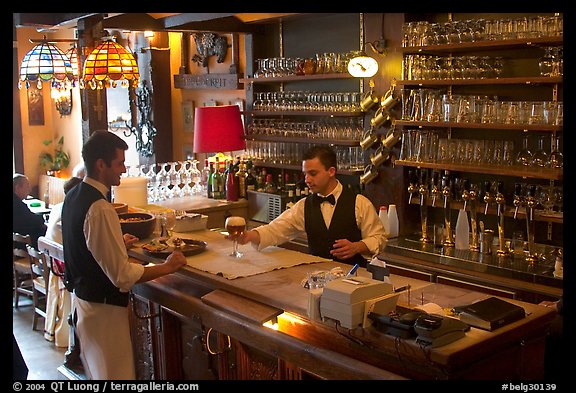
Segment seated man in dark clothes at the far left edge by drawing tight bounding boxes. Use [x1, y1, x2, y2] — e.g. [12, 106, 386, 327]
[12, 173, 46, 249]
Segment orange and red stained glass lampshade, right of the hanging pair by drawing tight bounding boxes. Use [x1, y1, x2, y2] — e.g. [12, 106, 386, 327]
[81, 38, 140, 89]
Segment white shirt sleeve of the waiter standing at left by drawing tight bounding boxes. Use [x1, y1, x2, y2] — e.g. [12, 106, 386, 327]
[84, 199, 144, 292]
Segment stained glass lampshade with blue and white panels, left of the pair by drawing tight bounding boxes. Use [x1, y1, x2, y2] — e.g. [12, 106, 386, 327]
[18, 42, 74, 89]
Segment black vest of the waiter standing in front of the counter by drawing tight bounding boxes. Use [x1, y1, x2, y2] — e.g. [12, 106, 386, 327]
[62, 182, 128, 307]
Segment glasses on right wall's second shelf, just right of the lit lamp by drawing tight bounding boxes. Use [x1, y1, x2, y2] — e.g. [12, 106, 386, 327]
[402, 55, 505, 80]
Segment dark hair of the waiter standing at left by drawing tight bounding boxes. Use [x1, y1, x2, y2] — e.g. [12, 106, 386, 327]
[82, 131, 128, 175]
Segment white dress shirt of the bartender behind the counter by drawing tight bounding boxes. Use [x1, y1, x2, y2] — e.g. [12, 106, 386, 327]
[255, 182, 388, 259]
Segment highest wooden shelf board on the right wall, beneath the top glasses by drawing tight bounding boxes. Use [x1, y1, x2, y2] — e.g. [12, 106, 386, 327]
[400, 36, 564, 54]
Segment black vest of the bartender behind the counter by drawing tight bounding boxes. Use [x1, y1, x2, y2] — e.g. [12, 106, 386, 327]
[304, 188, 366, 267]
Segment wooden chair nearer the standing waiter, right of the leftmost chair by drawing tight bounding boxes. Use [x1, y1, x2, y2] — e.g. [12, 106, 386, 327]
[26, 245, 50, 330]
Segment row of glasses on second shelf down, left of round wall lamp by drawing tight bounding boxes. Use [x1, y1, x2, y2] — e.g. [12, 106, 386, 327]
[252, 91, 361, 112]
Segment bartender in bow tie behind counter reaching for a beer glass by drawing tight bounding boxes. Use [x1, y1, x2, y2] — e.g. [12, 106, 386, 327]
[238, 145, 387, 267]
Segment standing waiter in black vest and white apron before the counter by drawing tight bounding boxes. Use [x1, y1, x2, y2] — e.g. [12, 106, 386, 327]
[62, 131, 186, 379]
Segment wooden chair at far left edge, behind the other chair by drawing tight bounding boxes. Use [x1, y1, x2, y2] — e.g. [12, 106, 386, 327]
[12, 232, 33, 308]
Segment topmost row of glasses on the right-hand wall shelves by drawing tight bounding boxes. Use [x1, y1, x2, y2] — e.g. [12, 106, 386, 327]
[402, 15, 563, 47]
